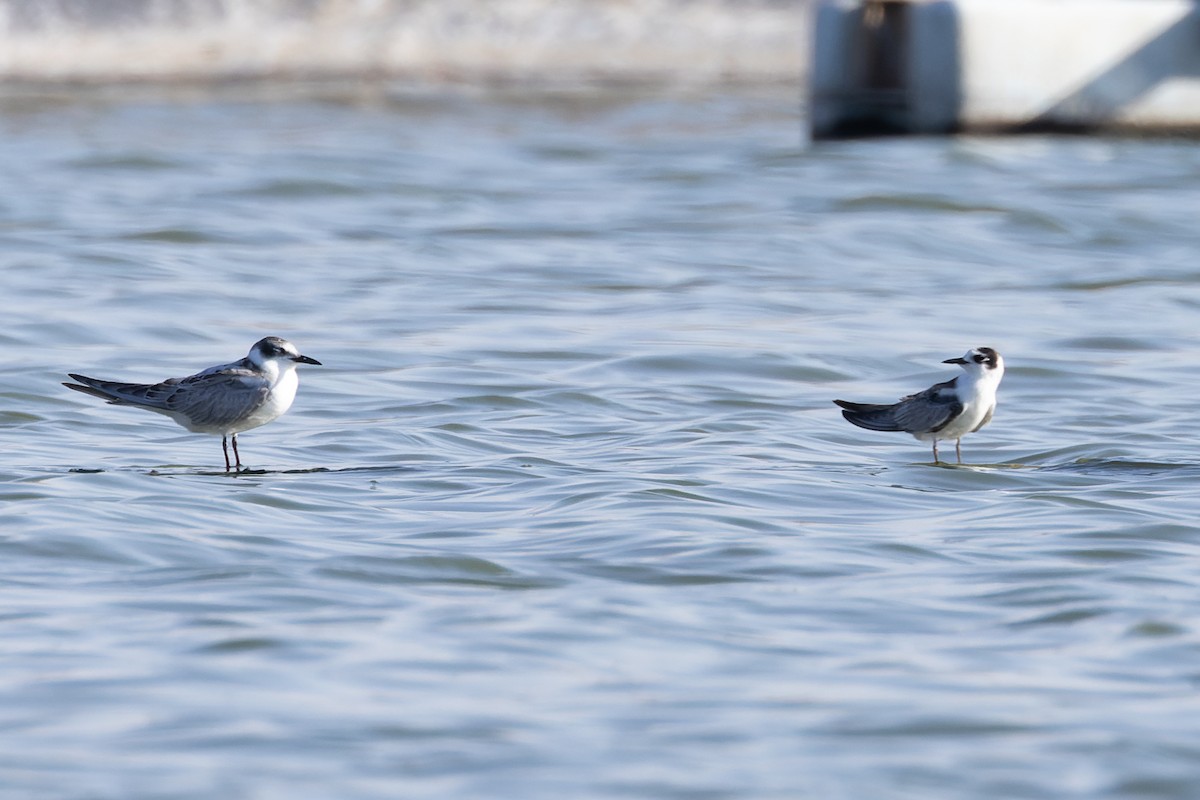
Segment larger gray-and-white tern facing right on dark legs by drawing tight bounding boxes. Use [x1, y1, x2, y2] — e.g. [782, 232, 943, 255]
[62, 336, 320, 473]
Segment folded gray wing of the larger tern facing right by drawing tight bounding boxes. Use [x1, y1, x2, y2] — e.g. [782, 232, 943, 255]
[155, 367, 271, 428]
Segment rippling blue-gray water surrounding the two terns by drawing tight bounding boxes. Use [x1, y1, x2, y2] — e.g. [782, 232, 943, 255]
[0, 86, 1200, 800]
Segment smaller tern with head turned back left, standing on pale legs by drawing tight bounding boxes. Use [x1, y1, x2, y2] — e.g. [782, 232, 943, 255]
[834, 347, 1004, 464]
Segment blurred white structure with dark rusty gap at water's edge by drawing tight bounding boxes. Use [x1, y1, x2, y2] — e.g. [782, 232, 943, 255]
[809, 0, 1200, 138]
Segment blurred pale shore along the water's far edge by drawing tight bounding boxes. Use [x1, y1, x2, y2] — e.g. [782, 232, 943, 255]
[0, 0, 809, 85]
